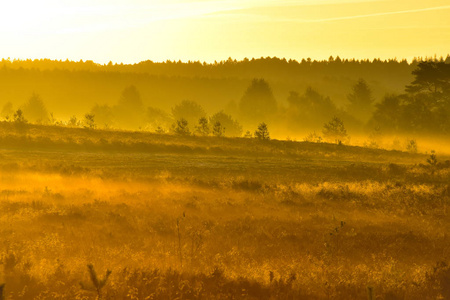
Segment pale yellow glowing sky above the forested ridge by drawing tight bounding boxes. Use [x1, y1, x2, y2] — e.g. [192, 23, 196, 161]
[0, 0, 450, 63]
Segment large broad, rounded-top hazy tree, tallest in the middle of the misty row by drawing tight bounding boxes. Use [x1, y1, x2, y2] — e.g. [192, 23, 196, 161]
[239, 79, 278, 122]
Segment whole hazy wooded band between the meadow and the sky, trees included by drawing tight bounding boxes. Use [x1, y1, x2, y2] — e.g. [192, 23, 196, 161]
[0, 56, 450, 138]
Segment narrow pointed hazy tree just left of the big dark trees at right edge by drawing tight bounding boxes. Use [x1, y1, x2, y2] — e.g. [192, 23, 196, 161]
[347, 78, 374, 121]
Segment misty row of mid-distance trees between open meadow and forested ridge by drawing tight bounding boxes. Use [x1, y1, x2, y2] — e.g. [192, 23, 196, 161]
[0, 60, 450, 142]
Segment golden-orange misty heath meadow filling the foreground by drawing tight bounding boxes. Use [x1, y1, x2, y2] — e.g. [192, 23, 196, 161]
[0, 122, 450, 299]
